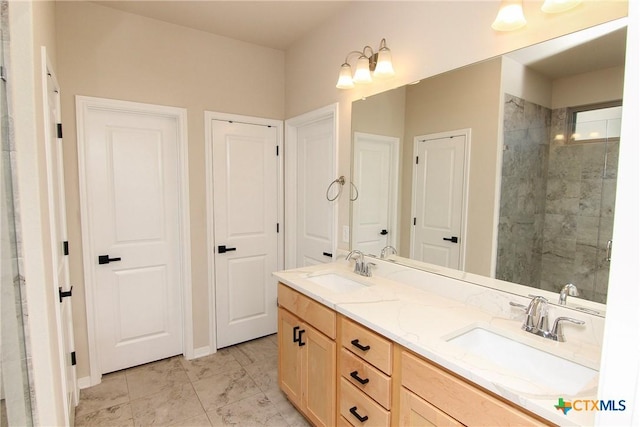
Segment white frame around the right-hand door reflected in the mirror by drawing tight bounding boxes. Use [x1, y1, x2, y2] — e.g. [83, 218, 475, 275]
[409, 128, 471, 271]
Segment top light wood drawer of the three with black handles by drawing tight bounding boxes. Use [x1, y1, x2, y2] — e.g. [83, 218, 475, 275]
[341, 317, 391, 375]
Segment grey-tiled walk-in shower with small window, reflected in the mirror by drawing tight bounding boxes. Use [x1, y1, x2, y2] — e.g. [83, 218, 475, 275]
[496, 95, 622, 303]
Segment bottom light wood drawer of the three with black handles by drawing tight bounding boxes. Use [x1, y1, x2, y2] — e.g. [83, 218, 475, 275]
[340, 378, 391, 427]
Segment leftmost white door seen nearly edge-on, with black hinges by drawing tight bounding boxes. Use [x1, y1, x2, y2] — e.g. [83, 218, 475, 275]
[42, 51, 79, 425]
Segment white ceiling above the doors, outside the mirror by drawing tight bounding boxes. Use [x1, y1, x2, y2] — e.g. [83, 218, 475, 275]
[94, 0, 350, 50]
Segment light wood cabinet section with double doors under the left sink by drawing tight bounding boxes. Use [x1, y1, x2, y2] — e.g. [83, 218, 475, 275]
[278, 285, 337, 426]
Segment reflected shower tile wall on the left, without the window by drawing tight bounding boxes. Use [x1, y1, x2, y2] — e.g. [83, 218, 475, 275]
[496, 94, 551, 287]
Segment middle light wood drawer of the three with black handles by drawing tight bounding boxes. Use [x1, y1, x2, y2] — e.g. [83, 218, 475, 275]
[340, 348, 391, 409]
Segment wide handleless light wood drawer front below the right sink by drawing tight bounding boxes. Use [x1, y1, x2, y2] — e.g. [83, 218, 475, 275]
[401, 352, 544, 426]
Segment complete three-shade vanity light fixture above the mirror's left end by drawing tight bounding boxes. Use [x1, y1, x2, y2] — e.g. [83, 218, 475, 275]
[336, 39, 395, 89]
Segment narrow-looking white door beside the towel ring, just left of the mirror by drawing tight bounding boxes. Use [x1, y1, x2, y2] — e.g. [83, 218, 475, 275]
[296, 117, 336, 267]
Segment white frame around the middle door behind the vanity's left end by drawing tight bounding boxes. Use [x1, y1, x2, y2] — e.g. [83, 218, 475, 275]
[206, 111, 286, 357]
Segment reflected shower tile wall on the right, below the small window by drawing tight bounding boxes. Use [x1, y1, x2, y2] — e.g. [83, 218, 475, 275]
[540, 108, 619, 303]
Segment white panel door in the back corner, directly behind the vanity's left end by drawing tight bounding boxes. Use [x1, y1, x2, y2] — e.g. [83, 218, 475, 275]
[212, 120, 279, 348]
